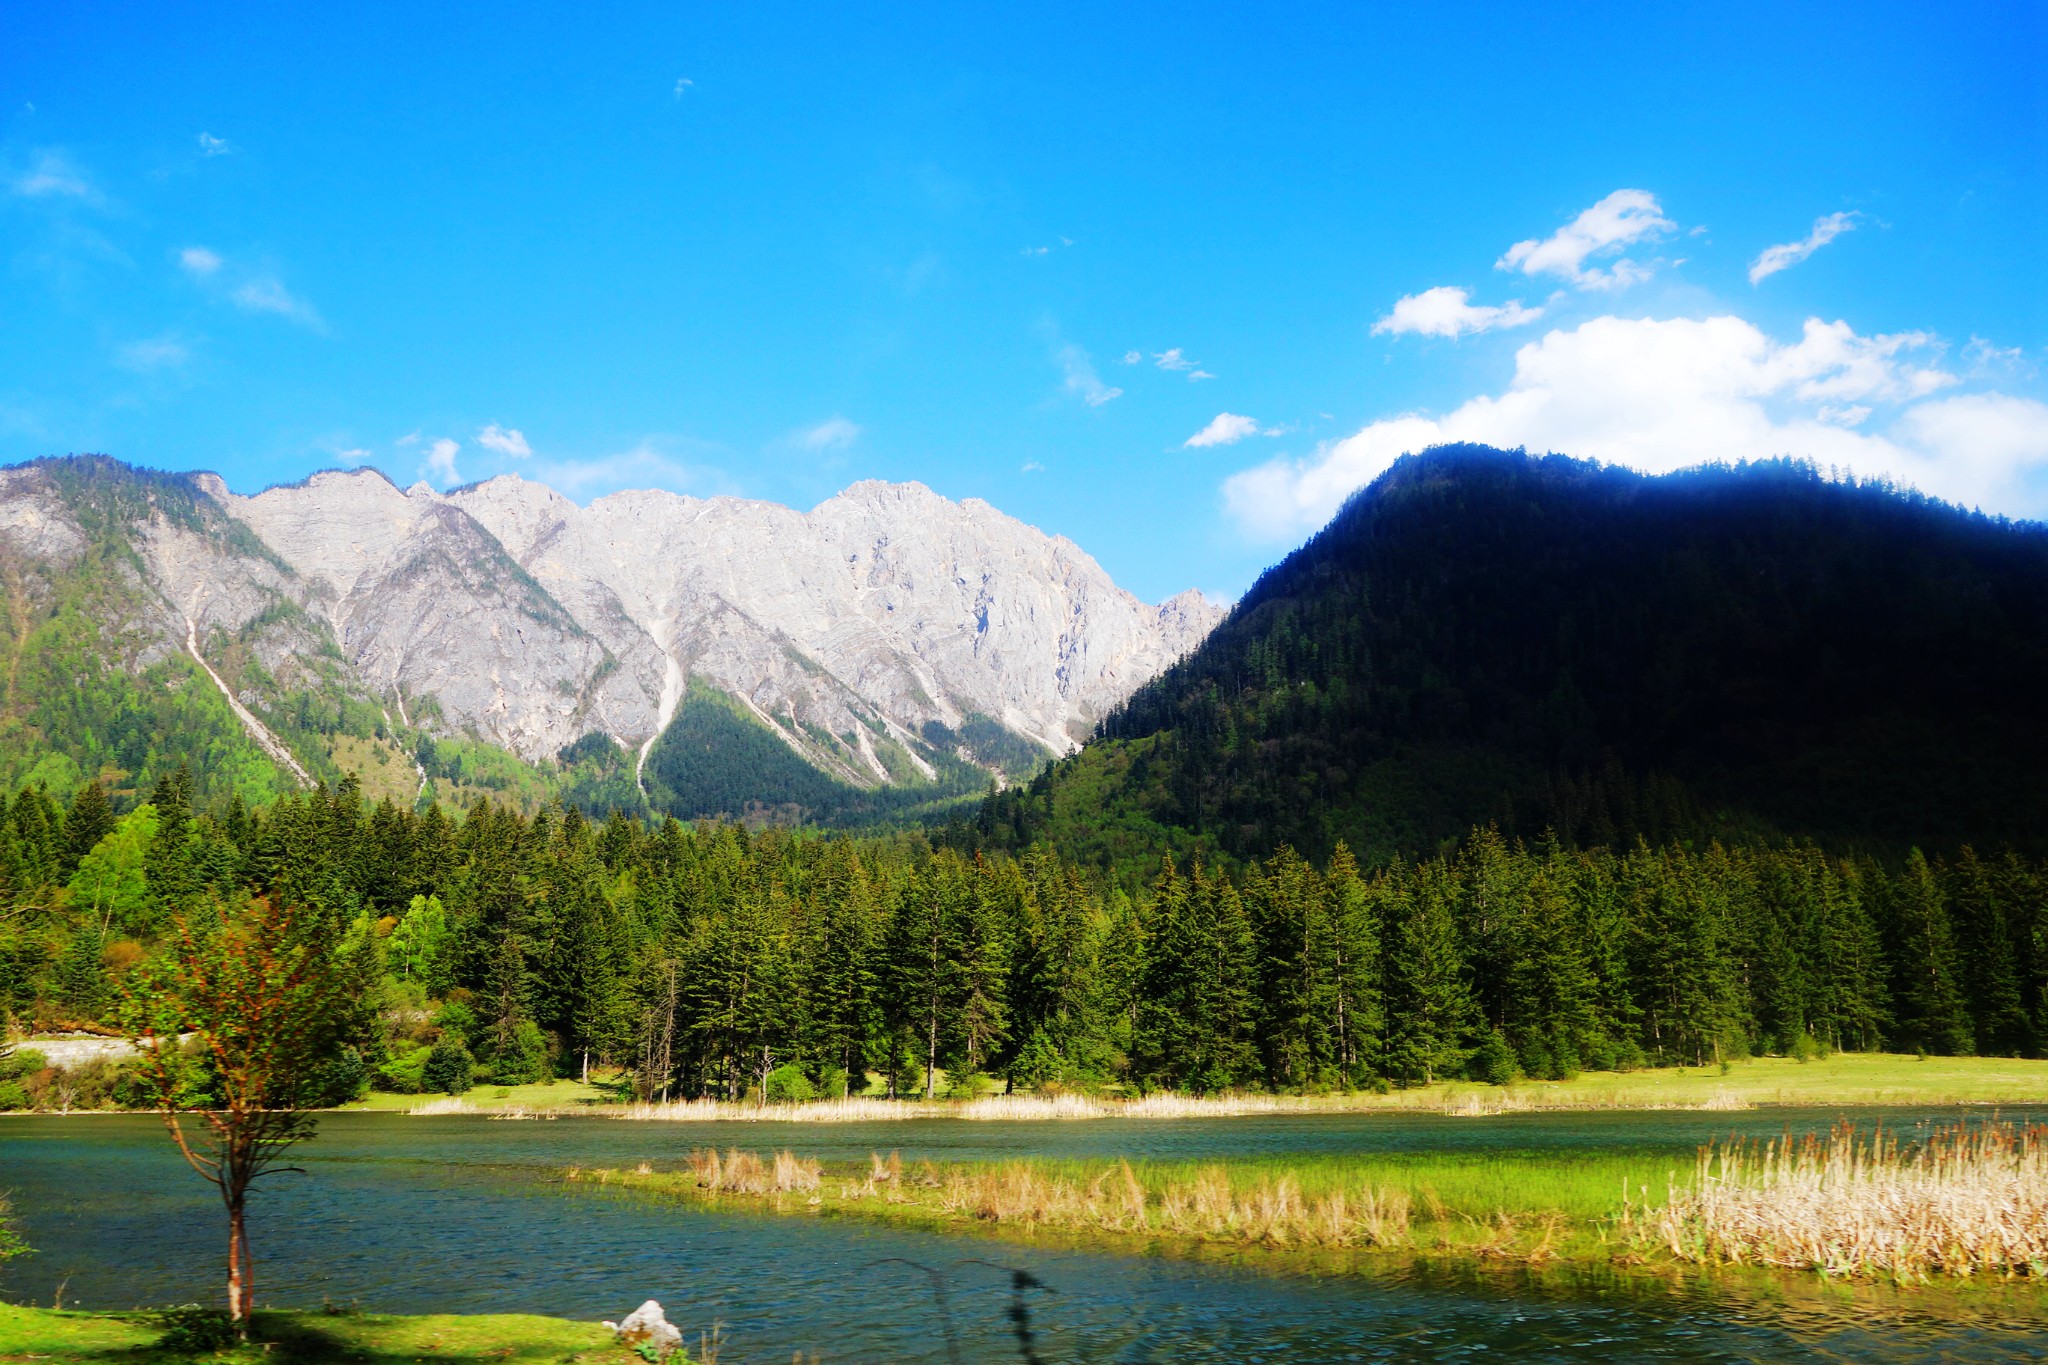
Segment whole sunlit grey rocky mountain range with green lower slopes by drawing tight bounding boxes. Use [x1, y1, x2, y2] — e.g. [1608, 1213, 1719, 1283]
[0, 456, 1223, 814]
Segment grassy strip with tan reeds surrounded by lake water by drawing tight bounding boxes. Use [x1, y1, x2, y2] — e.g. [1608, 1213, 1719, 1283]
[565, 1124, 2048, 1283]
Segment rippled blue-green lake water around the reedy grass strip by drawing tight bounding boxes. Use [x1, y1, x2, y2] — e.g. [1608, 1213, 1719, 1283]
[0, 1109, 2048, 1363]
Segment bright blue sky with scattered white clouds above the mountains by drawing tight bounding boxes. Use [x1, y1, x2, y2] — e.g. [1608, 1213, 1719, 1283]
[0, 0, 2048, 600]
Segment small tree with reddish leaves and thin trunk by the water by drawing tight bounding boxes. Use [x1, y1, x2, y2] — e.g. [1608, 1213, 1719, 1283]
[125, 898, 358, 1332]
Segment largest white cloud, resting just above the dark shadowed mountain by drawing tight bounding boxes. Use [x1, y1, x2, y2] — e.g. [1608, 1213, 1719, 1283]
[1223, 317, 2048, 540]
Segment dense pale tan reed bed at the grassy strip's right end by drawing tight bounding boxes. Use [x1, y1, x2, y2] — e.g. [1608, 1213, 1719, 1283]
[1630, 1124, 2048, 1283]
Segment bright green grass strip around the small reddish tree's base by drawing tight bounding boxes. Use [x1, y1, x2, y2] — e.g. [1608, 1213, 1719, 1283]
[0, 1304, 634, 1365]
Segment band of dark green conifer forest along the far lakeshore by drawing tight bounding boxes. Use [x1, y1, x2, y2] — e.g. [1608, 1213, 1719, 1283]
[0, 772, 2048, 1107]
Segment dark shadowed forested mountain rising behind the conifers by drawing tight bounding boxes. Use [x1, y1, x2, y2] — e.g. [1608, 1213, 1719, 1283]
[954, 446, 2048, 864]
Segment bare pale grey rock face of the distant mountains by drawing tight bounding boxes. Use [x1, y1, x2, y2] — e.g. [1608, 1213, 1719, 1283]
[0, 460, 1223, 786]
